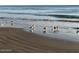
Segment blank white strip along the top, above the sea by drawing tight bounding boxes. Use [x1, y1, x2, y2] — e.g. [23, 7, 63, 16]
[0, 0, 79, 5]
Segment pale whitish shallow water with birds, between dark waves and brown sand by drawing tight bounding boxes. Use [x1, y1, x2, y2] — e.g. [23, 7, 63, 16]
[0, 20, 79, 42]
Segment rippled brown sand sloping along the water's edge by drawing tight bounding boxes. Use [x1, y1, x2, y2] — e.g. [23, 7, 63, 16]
[0, 28, 79, 53]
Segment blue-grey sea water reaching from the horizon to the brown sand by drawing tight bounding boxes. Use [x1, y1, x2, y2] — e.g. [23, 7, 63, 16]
[0, 5, 79, 42]
